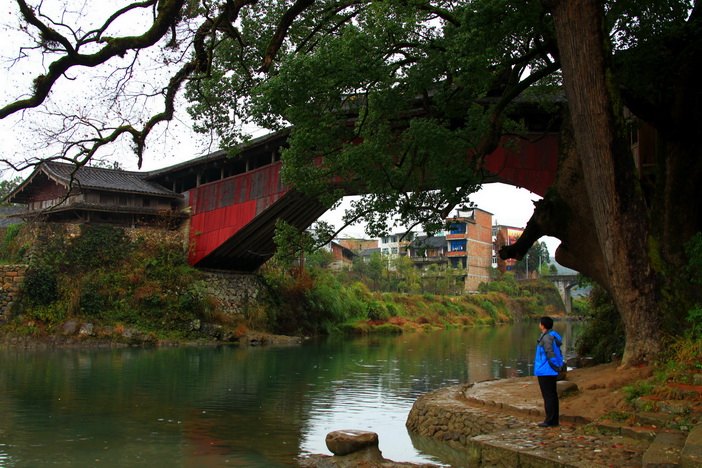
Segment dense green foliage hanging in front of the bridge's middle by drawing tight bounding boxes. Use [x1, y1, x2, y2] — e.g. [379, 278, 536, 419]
[188, 1, 555, 238]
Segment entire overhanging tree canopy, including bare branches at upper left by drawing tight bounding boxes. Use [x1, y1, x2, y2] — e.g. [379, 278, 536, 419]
[0, 0, 693, 238]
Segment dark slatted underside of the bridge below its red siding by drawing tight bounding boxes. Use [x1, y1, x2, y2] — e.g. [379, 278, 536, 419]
[195, 190, 326, 272]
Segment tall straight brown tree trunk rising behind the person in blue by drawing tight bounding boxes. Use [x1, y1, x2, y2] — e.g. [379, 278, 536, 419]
[545, 0, 661, 365]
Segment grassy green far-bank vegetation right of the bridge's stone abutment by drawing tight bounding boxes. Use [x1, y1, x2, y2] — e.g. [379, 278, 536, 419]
[248, 264, 563, 335]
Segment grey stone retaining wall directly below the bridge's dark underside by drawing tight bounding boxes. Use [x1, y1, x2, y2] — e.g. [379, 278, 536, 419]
[202, 271, 261, 321]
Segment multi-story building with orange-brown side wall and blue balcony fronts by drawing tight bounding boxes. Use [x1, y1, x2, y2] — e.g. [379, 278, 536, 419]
[446, 208, 493, 292]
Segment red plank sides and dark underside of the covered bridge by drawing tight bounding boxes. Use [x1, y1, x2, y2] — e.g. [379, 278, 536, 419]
[160, 128, 558, 272]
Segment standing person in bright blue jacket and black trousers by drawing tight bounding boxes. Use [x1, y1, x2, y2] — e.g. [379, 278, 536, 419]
[534, 317, 563, 427]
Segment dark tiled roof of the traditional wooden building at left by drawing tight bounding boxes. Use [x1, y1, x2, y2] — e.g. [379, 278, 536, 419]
[40, 161, 179, 197]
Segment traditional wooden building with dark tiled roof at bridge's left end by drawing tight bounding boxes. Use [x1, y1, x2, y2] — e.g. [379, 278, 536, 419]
[5, 161, 188, 227]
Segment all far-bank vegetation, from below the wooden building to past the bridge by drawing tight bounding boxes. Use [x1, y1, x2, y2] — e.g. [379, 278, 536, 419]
[1, 221, 562, 341]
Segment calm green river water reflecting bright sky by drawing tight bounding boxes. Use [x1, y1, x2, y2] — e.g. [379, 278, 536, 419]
[0, 323, 574, 467]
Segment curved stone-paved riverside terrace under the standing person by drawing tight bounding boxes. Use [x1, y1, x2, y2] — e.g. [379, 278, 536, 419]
[408, 382, 650, 467]
